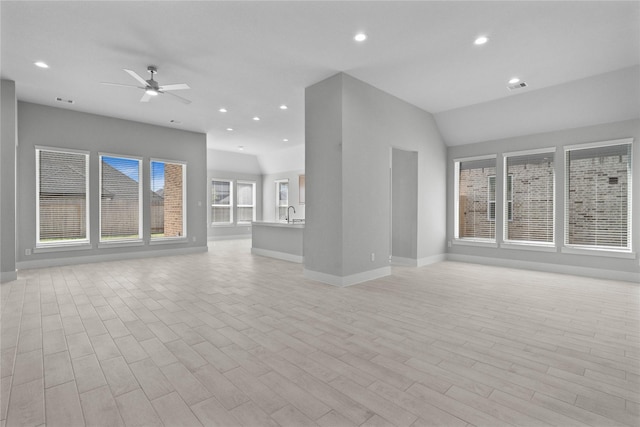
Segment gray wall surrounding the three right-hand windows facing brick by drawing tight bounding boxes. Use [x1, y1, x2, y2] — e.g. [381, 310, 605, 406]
[447, 119, 640, 280]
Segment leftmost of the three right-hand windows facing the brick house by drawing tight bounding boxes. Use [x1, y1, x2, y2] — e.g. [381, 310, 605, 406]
[455, 156, 496, 240]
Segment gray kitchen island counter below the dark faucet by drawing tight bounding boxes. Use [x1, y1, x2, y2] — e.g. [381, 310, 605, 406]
[251, 221, 304, 263]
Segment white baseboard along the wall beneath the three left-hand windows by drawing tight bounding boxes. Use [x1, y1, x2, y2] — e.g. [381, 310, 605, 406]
[16, 246, 208, 270]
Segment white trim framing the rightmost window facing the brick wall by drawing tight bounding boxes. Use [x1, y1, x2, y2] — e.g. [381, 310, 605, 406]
[554, 138, 635, 252]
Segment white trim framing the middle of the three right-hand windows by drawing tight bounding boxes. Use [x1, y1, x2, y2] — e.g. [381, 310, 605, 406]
[500, 147, 557, 246]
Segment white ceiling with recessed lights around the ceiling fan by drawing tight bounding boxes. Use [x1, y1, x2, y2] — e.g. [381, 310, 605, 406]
[0, 1, 640, 155]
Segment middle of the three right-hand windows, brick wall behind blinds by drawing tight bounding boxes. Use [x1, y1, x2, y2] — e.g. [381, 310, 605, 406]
[504, 150, 555, 243]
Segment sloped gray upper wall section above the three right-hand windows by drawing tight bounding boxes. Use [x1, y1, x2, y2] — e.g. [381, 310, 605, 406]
[435, 65, 640, 145]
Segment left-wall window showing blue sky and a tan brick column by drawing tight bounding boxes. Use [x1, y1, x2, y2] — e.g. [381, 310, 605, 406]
[151, 160, 187, 239]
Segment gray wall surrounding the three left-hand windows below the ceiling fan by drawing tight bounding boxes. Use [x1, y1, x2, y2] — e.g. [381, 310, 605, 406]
[17, 102, 208, 267]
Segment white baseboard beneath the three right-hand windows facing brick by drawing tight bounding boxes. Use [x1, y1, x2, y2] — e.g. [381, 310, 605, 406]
[446, 254, 640, 284]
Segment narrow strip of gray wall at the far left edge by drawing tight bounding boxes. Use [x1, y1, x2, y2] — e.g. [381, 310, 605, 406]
[0, 80, 17, 282]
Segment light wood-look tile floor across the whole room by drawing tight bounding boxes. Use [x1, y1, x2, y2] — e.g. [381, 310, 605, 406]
[0, 241, 640, 427]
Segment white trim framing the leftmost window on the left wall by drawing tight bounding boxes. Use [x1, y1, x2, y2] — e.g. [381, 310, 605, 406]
[34, 145, 91, 252]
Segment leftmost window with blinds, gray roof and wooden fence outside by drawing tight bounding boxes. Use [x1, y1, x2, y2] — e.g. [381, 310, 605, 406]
[36, 148, 89, 247]
